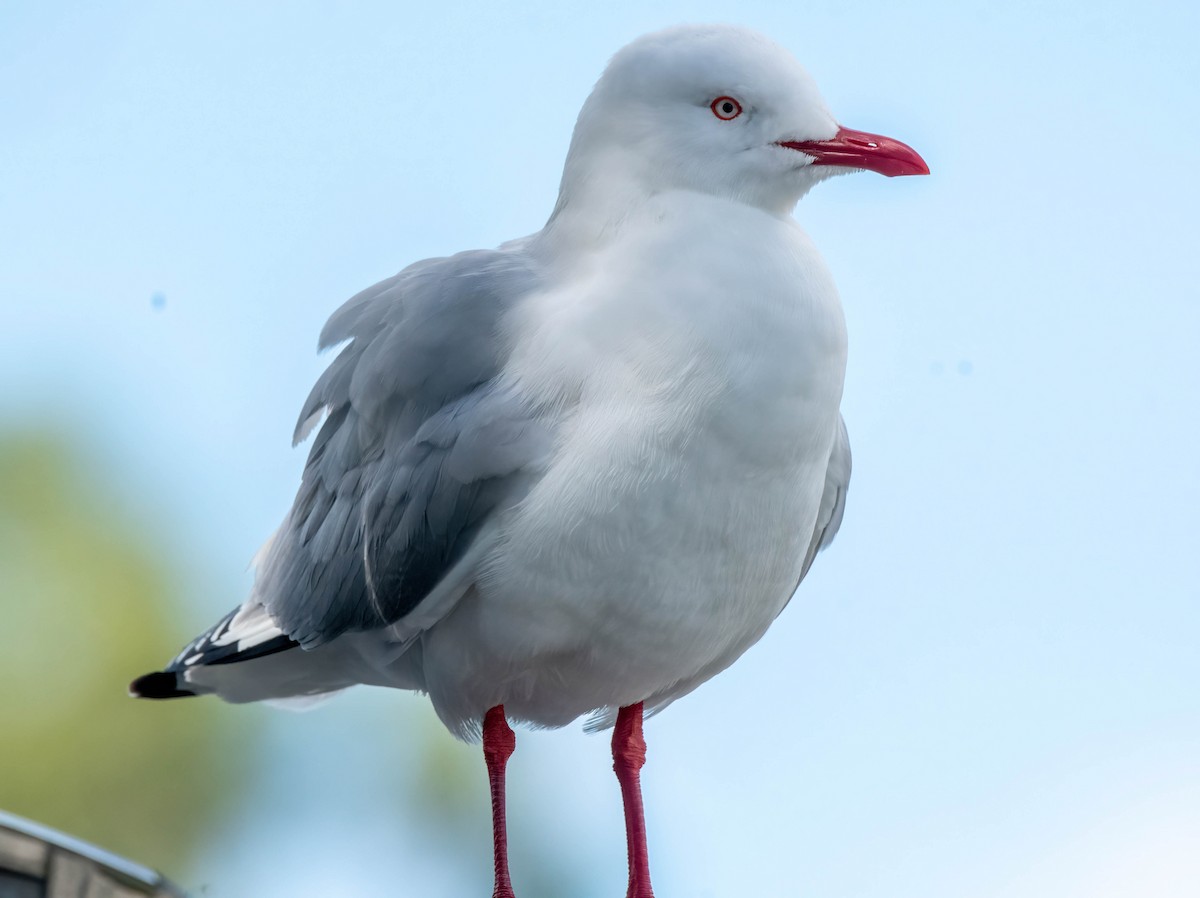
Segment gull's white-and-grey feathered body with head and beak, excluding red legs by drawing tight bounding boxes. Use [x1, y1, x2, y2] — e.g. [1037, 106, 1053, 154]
[134, 26, 923, 735]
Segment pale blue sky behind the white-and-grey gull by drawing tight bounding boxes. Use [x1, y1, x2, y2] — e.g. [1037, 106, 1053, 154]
[0, 0, 1200, 898]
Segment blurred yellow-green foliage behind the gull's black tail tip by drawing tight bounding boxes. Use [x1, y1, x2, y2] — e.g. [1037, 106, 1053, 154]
[0, 432, 253, 873]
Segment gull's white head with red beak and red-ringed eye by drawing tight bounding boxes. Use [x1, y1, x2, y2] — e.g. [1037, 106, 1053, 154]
[559, 25, 929, 220]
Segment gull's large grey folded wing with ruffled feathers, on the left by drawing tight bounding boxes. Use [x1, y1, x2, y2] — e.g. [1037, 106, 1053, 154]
[254, 249, 550, 648]
